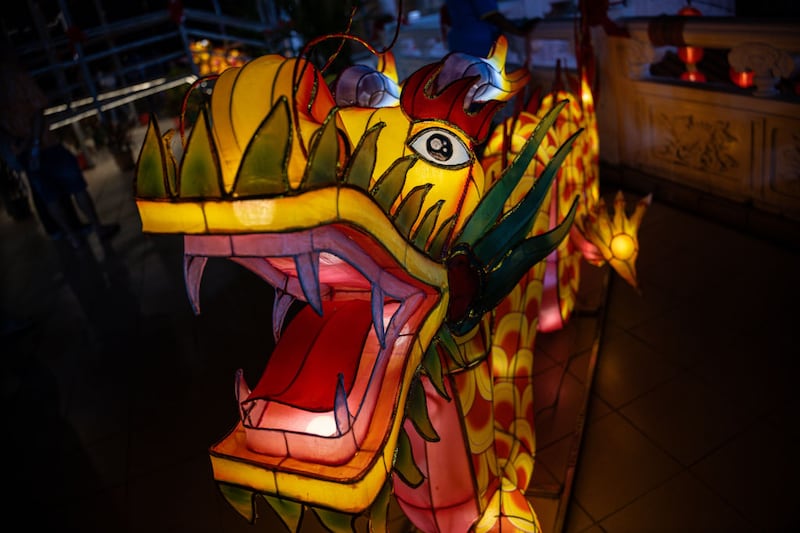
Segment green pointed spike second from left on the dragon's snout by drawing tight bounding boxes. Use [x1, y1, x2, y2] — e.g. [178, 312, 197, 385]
[178, 108, 222, 198]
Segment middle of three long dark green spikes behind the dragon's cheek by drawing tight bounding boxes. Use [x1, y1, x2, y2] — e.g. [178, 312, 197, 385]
[474, 130, 583, 270]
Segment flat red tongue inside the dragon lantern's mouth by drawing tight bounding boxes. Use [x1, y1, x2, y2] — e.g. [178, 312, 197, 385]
[247, 300, 372, 411]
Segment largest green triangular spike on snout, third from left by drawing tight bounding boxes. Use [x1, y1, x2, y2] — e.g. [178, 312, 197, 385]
[233, 96, 292, 197]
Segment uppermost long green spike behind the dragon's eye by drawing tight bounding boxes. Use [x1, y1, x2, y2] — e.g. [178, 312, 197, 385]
[456, 100, 567, 244]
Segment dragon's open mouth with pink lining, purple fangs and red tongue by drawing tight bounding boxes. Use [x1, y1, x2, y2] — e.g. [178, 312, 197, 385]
[184, 223, 442, 470]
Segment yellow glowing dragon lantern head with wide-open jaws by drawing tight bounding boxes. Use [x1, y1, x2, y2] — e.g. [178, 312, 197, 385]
[135, 36, 574, 527]
